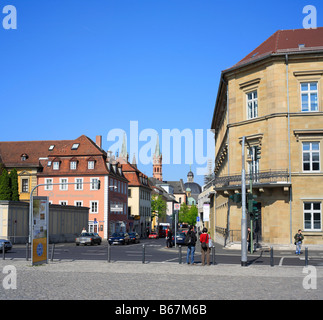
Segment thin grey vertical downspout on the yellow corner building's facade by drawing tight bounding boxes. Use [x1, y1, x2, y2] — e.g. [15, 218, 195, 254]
[285, 53, 293, 244]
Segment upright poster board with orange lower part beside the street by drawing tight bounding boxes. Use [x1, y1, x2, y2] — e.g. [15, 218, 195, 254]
[31, 197, 49, 265]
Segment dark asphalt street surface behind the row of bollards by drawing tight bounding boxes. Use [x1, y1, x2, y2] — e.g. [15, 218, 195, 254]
[4, 238, 323, 266]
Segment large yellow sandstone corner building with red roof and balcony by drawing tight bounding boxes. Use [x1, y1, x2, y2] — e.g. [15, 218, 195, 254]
[211, 28, 323, 244]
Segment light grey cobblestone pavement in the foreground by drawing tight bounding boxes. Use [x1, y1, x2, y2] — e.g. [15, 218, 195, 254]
[0, 260, 323, 300]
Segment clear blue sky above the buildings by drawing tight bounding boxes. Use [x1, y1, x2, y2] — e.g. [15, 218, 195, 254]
[0, 0, 323, 184]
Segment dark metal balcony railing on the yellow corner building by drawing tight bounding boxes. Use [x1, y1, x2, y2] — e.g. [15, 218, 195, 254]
[204, 170, 290, 189]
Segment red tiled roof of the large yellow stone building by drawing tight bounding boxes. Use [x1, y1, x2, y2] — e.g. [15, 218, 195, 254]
[230, 27, 323, 69]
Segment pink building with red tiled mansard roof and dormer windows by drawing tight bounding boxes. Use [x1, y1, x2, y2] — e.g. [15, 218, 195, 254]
[37, 135, 129, 239]
